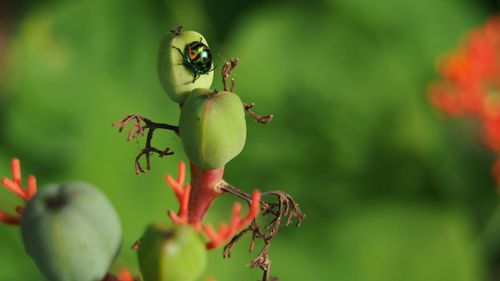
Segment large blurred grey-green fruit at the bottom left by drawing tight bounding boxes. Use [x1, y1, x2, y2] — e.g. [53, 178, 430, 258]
[21, 182, 121, 281]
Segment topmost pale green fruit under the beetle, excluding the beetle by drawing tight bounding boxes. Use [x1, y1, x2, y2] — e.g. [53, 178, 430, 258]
[157, 31, 214, 104]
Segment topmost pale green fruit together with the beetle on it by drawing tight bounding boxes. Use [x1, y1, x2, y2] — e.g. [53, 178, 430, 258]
[157, 31, 214, 104]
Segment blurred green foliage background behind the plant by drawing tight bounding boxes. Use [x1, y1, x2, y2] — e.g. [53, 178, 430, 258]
[0, 0, 500, 281]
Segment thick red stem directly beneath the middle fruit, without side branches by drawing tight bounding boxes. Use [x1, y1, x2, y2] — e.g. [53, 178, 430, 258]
[188, 162, 224, 225]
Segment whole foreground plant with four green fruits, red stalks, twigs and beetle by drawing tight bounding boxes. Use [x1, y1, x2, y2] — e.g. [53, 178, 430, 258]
[0, 25, 305, 281]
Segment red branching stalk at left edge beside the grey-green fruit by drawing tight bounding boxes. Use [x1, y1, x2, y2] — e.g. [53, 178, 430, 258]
[0, 158, 37, 225]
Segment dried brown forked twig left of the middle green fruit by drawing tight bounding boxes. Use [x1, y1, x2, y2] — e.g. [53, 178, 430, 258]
[113, 114, 179, 174]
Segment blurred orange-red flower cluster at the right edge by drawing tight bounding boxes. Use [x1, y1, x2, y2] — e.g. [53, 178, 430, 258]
[429, 17, 500, 188]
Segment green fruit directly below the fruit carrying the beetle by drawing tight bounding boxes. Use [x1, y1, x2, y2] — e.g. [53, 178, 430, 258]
[179, 89, 247, 169]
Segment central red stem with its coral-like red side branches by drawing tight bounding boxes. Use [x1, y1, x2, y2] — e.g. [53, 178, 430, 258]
[165, 162, 261, 249]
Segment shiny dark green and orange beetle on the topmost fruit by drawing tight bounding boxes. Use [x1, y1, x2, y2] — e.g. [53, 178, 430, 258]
[172, 38, 214, 83]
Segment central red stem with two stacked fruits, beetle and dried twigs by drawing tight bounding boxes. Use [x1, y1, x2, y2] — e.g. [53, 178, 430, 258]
[114, 27, 304, 281]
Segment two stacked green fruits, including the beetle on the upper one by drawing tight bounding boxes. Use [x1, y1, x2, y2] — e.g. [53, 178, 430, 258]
[158, 28, 246, 169]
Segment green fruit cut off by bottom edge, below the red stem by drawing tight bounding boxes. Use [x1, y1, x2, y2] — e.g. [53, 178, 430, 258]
[137, 224, 207, 281]
